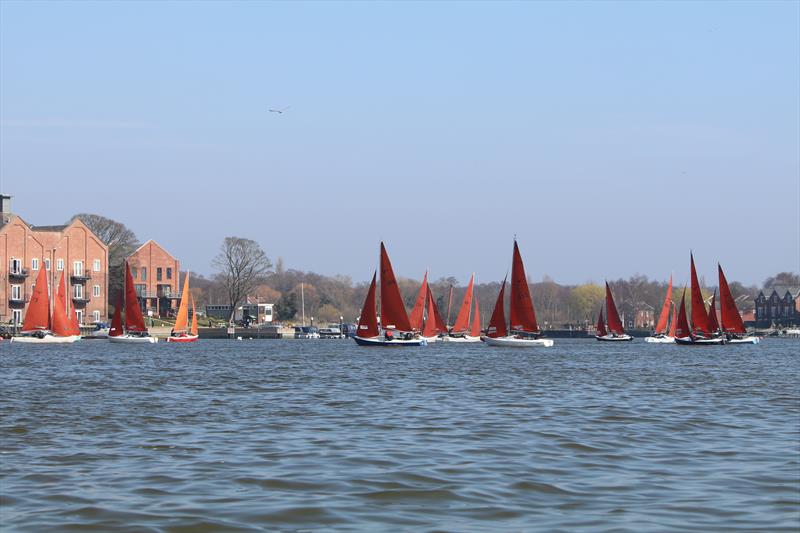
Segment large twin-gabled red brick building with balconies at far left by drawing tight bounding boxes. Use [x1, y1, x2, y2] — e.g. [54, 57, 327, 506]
[0, 195, 108, 326]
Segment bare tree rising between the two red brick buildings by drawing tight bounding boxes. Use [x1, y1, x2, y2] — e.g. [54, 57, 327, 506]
[69, 213, 140, 305]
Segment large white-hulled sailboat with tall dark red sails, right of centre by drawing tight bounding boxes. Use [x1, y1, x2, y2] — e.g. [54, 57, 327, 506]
[481, 239, 553, 348]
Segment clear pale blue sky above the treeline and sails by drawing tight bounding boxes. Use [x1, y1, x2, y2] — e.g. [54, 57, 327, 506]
[0, 0, 800, 284]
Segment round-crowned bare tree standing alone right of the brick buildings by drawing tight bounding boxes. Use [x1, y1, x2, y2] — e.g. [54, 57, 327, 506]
[212, 237, 272, 321]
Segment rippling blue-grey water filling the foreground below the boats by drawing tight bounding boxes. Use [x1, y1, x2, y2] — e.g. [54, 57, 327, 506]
[0, 340, 800, 533]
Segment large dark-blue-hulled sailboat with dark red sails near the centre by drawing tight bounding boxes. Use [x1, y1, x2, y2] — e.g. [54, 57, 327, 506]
[353, 242, 428, 346]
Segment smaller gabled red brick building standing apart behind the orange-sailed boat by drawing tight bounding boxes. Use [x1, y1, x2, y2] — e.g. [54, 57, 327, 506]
[127, 239, 181, 317]
